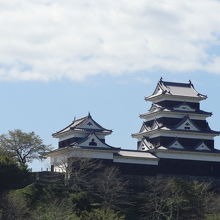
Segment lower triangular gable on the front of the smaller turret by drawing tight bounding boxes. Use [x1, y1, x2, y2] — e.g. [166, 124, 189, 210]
[71, 132, 120, 149]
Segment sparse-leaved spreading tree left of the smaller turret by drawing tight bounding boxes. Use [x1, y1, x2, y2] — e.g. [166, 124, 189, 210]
[0, 129, 50, 166]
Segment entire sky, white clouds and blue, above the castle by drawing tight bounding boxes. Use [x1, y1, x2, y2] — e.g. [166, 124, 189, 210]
[0, 0, 220, 170]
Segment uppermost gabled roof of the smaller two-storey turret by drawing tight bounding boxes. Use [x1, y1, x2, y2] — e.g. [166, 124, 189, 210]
[52, 113, 112, 137]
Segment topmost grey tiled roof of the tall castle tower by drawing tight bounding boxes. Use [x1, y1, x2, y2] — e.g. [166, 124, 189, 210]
[145, 78, 207, 100]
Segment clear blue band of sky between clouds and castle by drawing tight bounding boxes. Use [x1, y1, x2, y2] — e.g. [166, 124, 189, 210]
[0, 71, 220, 170]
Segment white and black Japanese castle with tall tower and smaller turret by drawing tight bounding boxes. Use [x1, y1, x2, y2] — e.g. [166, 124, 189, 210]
[48, 78, 220, 177]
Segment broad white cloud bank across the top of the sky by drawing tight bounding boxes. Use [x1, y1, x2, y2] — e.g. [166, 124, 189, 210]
[0, 0, 220, 81]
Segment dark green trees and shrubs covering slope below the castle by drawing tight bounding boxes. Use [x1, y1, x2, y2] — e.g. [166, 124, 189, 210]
[0, 156, 220, 220]
